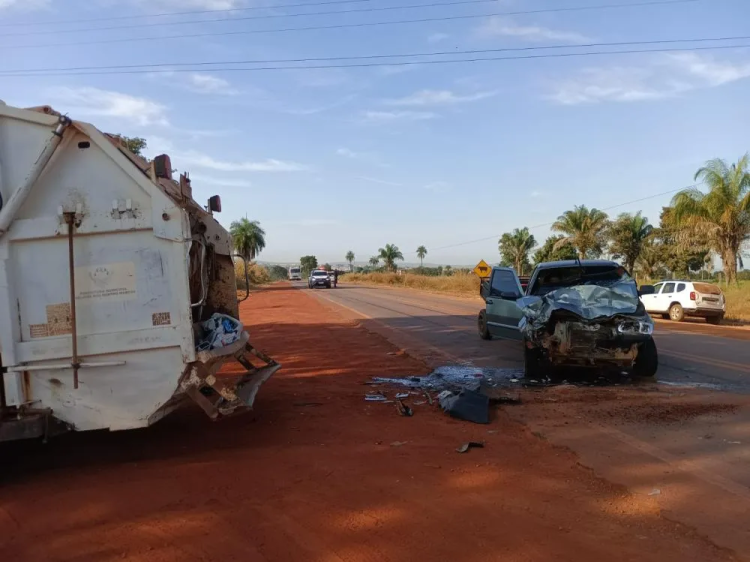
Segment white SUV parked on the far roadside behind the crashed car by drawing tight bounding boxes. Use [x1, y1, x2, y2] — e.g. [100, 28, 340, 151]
[641, 281, 726, 324]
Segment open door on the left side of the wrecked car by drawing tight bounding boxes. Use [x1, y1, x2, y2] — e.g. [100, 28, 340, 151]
[486, 267, 523, 340]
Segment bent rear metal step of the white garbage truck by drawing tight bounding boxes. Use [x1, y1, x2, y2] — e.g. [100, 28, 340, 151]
[179, 332, 281, 420]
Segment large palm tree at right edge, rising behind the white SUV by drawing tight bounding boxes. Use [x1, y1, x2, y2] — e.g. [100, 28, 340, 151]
[672, 154, 750, 283]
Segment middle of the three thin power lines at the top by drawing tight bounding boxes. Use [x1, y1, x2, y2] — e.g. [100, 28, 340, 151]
[0, 0, 506, 37]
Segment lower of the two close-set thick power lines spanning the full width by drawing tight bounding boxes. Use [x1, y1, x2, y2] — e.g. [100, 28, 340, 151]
[0, 43, 750, 78]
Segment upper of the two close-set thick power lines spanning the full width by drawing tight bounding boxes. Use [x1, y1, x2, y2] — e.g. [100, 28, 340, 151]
[0, 35, 750, 75]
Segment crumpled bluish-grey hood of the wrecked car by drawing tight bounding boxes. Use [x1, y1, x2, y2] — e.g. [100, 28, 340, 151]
[518, 279, 639, 335]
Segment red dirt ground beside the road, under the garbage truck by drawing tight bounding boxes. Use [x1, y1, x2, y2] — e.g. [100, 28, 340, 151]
[0, 285, 737, 562]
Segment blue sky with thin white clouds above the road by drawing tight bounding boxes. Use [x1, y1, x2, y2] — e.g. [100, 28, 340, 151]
[0, 0, 750, 265]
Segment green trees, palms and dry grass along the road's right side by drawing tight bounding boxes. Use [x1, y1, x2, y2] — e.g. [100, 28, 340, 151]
[346, 154, 750, 321]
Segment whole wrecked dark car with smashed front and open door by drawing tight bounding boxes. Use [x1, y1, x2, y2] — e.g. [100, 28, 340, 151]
[478, 260, 658, 379]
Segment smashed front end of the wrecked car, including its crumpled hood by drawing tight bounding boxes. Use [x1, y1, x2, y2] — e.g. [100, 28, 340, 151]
[519, 278, 654, 368]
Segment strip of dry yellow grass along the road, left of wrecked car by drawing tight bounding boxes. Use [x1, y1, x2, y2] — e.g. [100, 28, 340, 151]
[341, 272, 479, 297]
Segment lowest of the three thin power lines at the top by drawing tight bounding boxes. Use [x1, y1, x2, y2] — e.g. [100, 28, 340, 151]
[2, 0, 704, 49]
